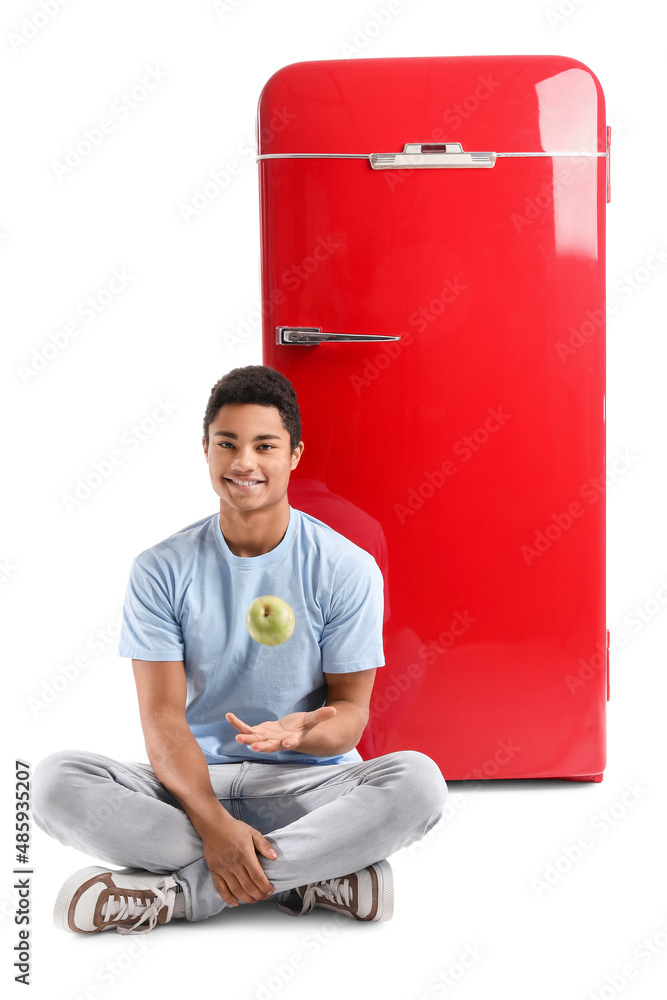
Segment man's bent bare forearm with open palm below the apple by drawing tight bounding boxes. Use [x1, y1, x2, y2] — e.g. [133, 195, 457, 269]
[226, 668, 375, 757]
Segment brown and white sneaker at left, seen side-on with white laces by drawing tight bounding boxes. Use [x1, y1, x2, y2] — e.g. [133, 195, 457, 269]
[53, 867, 182, 934]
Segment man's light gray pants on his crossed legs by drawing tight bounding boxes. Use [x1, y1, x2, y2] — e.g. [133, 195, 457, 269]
[33, 750, 447, 920]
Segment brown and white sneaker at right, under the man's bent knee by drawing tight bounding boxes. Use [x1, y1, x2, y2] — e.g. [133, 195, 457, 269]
[277, 861, 394, 920]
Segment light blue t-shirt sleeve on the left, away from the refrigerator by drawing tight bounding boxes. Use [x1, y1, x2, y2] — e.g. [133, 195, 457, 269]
[118, 558, 184, 660]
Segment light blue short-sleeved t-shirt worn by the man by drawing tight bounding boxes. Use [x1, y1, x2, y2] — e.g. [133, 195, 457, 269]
[118, 507, 384, 764]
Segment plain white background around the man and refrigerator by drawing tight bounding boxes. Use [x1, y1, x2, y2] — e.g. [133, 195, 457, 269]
[0, 0, 667, 1000]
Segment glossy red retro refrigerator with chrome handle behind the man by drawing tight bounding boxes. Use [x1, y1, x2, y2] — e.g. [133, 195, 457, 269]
[257, 56, 609, 781]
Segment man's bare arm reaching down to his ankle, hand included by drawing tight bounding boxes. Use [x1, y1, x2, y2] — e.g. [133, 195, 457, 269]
[132, 660, 277, 906]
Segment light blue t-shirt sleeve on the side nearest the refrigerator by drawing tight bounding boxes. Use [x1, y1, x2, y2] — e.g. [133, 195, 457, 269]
[320, 554, 384, 674]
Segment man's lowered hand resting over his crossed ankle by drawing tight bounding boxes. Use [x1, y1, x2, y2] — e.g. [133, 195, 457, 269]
[202, 816, 278, 906]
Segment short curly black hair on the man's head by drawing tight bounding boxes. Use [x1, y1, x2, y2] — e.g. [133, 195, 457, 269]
[204, 365, 301, 451]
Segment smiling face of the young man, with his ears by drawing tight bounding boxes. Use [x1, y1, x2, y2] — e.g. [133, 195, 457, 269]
[203, 403, 303, 514]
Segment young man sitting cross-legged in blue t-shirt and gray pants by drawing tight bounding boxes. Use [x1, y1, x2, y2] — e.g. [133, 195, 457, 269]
[33, 365, 447, 934]
